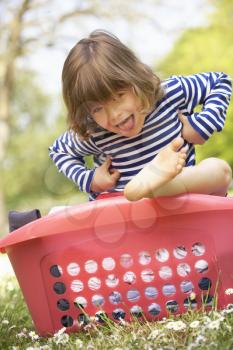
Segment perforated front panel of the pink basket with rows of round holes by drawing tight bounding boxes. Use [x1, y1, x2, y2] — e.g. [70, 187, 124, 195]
[42, 241, 217, 327]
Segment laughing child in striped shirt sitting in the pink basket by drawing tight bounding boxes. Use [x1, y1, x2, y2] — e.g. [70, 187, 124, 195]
[50, 30, 232, 200]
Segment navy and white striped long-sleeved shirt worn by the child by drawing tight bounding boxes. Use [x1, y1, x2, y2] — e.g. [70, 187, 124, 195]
[49, 73, 232, 200]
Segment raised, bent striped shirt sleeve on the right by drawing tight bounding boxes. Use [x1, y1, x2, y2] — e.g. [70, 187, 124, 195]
[177, 72, 232, 140]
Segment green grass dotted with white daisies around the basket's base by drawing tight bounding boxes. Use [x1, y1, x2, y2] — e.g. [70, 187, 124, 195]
[0, 277, 233, 350]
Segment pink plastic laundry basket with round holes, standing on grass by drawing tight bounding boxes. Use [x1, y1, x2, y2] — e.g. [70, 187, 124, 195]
[0, 194, 233, 335]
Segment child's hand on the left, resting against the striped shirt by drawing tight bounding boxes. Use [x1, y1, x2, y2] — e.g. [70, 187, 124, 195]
[91, 158, 120, 192]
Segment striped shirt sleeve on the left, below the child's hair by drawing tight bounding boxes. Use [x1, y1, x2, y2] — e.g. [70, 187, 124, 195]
[49, 131, 101, 193]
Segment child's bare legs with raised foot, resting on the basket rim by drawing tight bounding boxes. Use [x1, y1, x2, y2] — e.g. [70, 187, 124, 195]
[124, 138, 232, 201]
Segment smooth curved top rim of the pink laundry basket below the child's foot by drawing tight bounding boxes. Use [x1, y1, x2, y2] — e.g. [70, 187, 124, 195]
[0, 193, 233, 253]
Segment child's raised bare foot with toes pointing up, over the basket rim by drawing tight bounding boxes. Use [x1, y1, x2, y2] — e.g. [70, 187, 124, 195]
[124, 137, 187, 201]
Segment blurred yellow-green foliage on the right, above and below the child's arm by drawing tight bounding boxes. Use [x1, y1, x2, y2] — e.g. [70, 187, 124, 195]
[156, 0, 233, 164]
